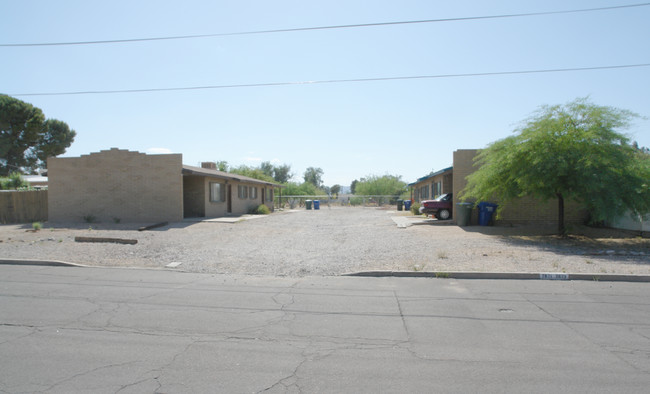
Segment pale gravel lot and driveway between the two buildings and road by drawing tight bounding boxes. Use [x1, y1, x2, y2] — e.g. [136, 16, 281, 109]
[0, 207, 650, 276]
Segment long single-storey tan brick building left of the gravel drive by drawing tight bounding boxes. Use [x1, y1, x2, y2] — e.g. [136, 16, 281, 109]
[48, 148, 280, 222]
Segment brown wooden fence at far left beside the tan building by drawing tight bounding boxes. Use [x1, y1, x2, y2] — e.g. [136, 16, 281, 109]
[0, 190, 47, 224]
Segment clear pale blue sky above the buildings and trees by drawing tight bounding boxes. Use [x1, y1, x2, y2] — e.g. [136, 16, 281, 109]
[0, 0, 650, 186]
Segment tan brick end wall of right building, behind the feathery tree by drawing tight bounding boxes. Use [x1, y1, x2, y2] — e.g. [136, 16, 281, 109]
[453, 149, 588, 224]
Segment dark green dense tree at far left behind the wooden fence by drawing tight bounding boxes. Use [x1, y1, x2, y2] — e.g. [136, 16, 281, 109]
[0, 95, 76, 176]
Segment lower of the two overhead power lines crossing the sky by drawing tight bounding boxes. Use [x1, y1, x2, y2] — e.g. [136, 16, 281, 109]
[9, 63, 650, 96]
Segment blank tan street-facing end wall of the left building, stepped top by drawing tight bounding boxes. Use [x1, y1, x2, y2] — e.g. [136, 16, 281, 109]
[48, 148, 183, 222]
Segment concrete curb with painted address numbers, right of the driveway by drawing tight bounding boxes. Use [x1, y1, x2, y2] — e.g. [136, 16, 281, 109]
[342, 271, 650, 282]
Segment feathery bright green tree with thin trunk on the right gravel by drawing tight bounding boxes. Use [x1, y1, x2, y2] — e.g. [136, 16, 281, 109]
[462, 98, 650, 235]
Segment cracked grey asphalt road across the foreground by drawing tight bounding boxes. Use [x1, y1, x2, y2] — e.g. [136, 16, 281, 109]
[0, 265, 650, 393]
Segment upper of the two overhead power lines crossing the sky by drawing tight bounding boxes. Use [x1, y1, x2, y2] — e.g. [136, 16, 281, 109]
[0, 3, 650, 47]
